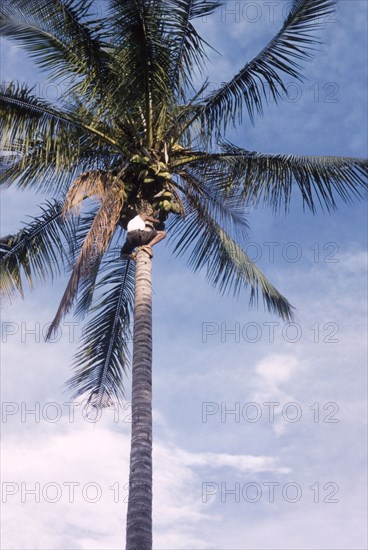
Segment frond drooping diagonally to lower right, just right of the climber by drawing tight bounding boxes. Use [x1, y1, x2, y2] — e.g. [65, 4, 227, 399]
[168, 197, 294, 321]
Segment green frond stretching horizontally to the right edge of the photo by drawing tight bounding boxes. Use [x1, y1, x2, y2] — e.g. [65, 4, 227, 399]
[207, 143, 368, 212]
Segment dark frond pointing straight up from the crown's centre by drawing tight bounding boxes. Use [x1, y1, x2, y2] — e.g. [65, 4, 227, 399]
[109, 0, 172, 148]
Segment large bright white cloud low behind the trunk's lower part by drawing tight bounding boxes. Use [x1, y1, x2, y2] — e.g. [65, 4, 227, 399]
[2, 416, 288, 550]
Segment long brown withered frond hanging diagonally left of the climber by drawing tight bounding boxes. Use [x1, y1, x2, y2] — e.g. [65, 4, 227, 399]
[46, 189, 123, 339]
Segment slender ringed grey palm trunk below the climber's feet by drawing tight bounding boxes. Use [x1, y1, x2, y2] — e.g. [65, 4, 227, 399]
[126, 250, 152, 550]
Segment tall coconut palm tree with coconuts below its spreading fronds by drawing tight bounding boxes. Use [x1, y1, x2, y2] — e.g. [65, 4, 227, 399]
[0, 0, 367, 550]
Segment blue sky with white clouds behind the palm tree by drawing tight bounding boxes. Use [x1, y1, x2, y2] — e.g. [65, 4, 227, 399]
[1, 0, 367, 550]
